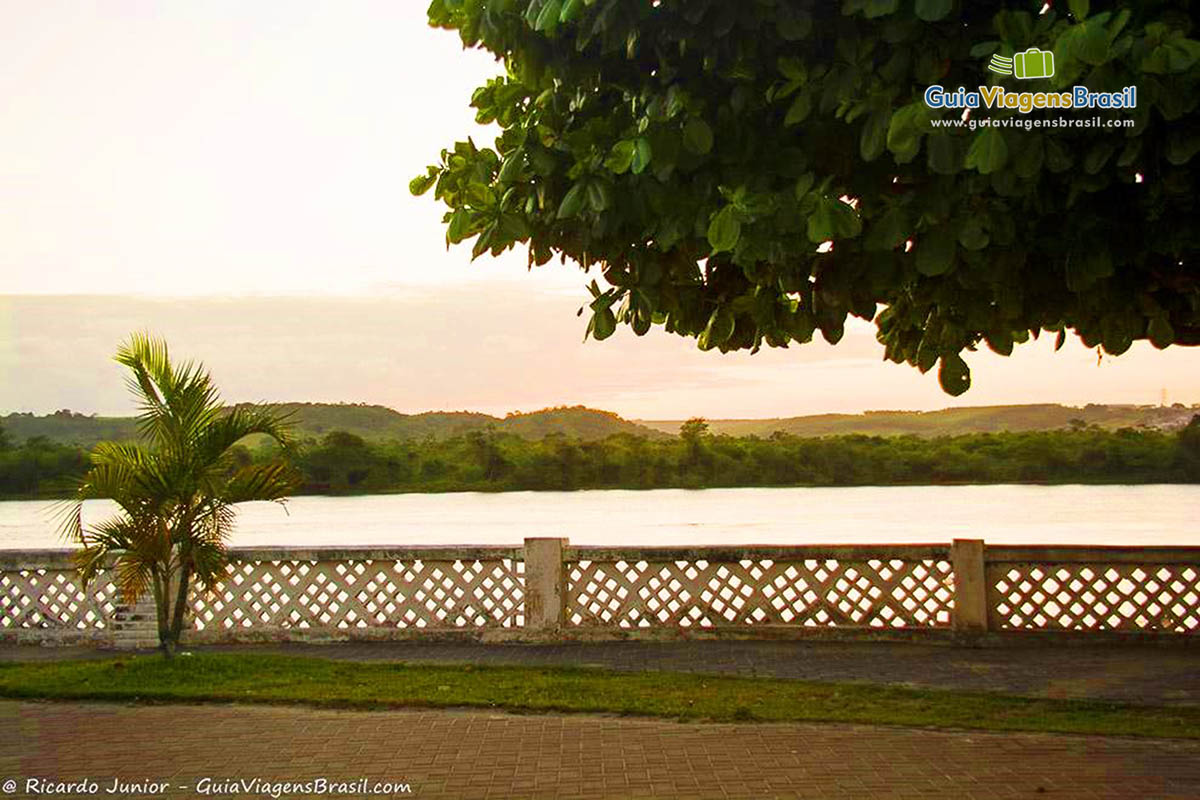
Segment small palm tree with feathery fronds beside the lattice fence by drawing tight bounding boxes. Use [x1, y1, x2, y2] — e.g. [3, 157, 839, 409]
[62, 333, 296, 658]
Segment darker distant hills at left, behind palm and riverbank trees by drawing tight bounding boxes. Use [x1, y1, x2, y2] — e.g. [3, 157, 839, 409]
[0, 403, 664, 447]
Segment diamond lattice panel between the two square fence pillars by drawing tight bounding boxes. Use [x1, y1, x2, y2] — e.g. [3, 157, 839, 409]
[566, 559, 954, 627]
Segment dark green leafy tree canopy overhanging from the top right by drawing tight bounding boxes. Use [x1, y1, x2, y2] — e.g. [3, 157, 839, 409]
[410, 0, 1200, 395]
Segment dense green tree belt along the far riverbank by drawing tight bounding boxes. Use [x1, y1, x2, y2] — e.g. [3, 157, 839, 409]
[0, 416, 1200, 497]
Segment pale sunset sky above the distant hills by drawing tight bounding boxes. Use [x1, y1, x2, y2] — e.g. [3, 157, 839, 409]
[0, 0, 1200, 419]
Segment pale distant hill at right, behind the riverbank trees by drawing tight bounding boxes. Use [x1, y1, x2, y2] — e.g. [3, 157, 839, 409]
[635, 404, 1200, 437]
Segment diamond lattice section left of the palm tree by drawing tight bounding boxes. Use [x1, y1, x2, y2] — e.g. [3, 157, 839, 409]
[0, 570, 120, 630]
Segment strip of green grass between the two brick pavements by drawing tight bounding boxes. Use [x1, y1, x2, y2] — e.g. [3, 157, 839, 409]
[0, 654, 1200, 739]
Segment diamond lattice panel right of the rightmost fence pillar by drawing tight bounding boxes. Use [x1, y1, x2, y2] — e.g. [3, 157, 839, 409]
[988, 564, 1200, 633]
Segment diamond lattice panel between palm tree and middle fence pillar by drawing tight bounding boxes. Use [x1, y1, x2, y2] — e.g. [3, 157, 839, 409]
[193, 559, 524, 630]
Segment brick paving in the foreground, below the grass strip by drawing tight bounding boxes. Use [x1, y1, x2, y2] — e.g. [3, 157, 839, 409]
[0, 702, 1200, 799]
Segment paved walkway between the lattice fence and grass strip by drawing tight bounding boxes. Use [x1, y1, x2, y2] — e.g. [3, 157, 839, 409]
[7, 642, 1200, 705]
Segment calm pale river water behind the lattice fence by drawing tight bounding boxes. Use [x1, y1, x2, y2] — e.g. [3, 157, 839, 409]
[0, 486, 1200, 549]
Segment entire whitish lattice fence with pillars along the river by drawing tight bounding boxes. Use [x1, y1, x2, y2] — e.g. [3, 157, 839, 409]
[0, 540, 1200, 642]
